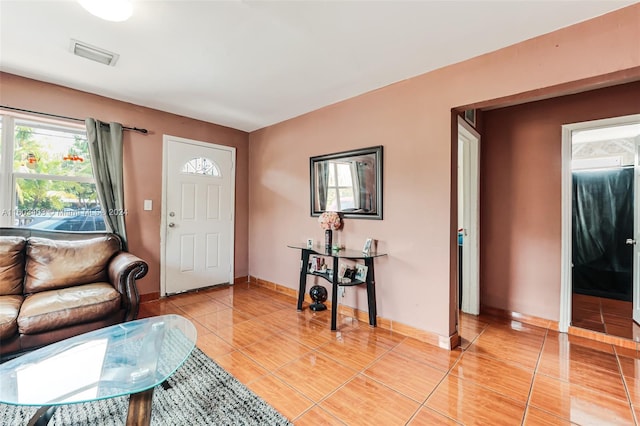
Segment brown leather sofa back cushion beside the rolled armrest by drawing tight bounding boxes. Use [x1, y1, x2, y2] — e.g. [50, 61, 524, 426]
[24, 235, 120, 293]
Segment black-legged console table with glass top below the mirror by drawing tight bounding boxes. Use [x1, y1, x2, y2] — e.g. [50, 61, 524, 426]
[287, 244, 387, 331]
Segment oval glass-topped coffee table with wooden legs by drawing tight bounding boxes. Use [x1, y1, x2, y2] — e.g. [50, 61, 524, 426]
[0, 315, 197, 425]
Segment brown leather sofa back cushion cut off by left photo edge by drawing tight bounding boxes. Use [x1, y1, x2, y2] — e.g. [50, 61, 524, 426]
[0, 236, 27, 295]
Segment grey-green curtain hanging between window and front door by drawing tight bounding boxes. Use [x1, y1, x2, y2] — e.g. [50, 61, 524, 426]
[85, 118, 127, 250]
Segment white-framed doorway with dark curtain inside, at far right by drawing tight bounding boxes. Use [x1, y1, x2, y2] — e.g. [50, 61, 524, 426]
[560, 115, 640, 340]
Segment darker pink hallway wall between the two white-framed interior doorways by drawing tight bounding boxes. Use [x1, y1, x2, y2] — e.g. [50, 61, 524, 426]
[480, 82, 640, 321]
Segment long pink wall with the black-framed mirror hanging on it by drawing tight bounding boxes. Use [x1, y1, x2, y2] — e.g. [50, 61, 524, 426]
[249, 4, 640, 336]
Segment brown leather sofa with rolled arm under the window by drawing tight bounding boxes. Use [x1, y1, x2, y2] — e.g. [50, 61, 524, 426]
[0, 228, 148, 359]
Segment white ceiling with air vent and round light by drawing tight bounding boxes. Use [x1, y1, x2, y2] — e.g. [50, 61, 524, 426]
[0, 0, 636, 131]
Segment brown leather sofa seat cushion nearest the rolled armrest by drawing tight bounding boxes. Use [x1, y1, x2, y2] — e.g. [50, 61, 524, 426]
[18, 282, 121, 334]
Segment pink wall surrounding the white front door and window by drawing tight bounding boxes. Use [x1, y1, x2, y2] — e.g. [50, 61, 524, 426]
[0, 73, 249, 294]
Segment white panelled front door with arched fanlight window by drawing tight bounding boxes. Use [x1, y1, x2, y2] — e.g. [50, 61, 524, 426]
[162, 136, 235, 294]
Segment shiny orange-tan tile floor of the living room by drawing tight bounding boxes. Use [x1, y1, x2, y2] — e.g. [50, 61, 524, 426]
[140, 284, 640, 426]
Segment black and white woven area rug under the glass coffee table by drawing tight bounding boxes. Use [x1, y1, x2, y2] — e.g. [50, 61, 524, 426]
[0, 348, 292, 426]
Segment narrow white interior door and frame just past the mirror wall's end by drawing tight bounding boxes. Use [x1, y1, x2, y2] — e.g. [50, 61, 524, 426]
[458, 119, 480, 315]
